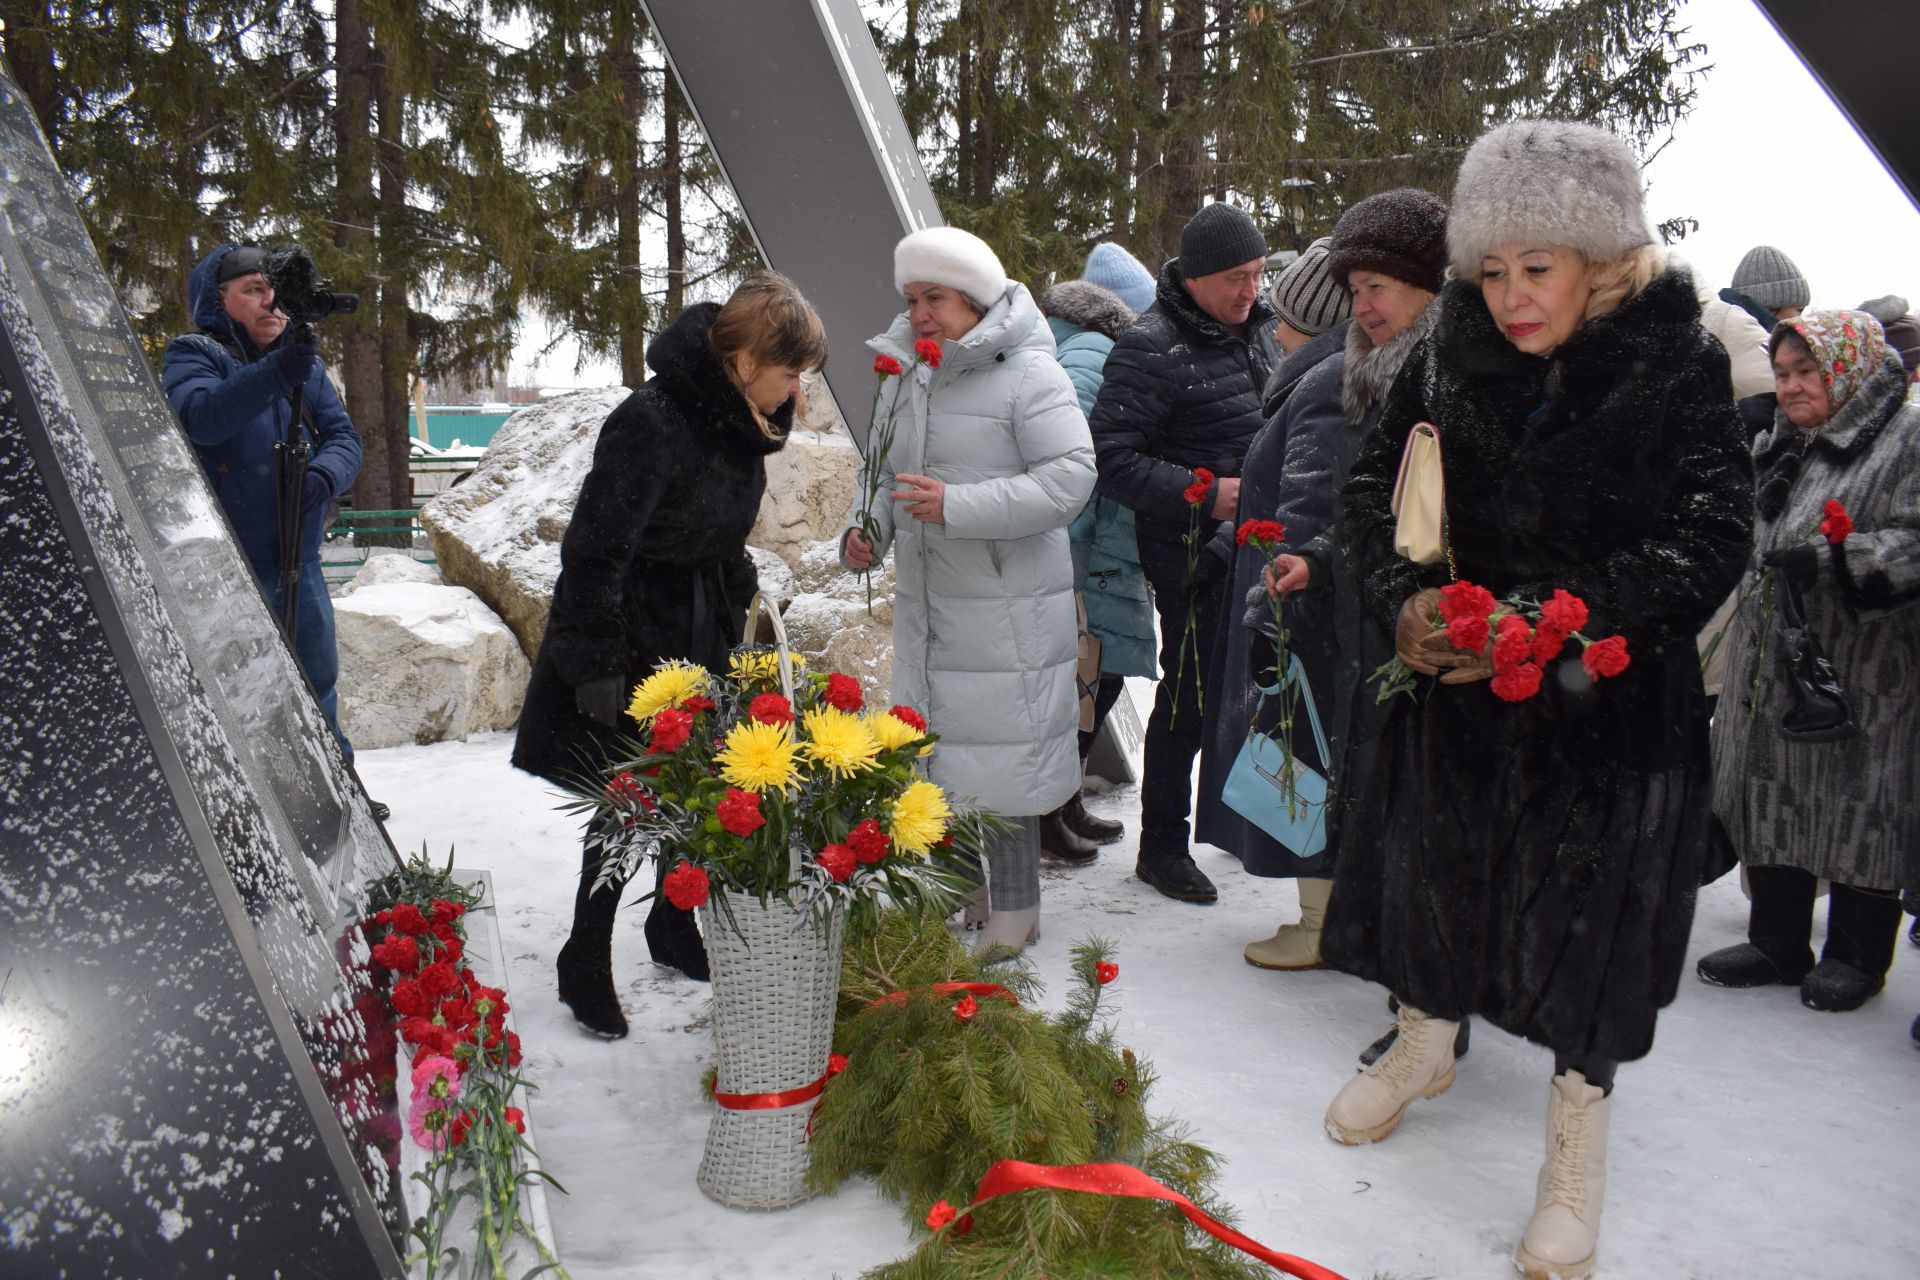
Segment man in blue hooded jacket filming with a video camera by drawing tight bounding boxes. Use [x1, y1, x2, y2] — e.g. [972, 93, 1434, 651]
[161, 244, 364, 759]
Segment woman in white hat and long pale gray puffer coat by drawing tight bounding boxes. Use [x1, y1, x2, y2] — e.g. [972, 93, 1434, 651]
[841, 226, 1094, 950]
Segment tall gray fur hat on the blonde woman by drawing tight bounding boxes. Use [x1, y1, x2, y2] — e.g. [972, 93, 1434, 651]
[1446, 121, 1653, 280]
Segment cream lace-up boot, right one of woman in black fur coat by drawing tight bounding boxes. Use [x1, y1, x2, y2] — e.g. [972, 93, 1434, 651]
[1513, 1071, 1613, 1280]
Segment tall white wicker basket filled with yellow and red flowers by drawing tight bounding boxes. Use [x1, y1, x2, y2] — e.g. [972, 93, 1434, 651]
[576, 602, 1002, 1209]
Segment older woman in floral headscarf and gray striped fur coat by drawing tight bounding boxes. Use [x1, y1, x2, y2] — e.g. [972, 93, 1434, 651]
[1699, 311, 1920, 1011]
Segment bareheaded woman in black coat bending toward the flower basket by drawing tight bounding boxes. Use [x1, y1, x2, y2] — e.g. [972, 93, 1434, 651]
[513, 273, 828, 1038]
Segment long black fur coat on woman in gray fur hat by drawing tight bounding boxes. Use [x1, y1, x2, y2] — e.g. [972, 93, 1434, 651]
[1321, 271, 1753, 1059]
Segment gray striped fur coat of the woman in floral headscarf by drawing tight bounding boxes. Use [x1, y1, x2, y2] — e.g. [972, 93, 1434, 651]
[1713, 355, 1920, 894]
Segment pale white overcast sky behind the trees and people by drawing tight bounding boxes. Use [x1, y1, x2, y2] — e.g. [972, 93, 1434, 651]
[515, 0, 1920, 386]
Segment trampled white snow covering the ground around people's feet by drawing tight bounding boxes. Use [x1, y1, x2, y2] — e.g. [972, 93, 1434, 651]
[357, 733, 1920, 1280]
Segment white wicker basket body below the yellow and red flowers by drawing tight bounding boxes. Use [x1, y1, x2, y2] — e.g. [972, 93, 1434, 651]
[697, 896, 847, 1209]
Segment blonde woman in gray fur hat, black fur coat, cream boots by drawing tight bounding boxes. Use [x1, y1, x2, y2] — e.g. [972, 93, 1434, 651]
[1321, 121, 1753, 1280]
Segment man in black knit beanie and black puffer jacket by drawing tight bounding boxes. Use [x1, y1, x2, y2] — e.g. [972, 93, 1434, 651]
[1089, 203, 1275, 902]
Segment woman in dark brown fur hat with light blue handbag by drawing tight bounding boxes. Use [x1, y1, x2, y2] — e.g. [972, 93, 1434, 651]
[1240, 186, 1446, 969]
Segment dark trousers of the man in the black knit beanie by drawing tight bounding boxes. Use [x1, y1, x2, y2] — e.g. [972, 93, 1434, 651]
[1140, 537, 1221, 854]
